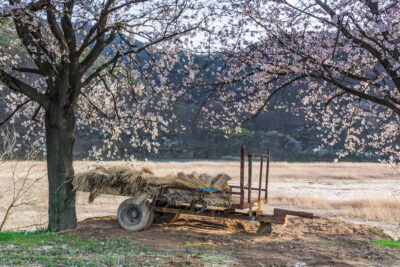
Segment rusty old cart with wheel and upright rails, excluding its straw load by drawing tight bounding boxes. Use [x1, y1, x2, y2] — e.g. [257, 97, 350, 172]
[118, 146, 315, 234]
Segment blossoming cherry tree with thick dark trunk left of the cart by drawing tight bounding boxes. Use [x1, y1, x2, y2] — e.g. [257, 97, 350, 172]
[0, 0, 211, 231]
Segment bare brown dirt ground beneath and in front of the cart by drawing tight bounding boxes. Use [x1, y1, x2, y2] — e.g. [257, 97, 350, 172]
[63, 216, 400, 267]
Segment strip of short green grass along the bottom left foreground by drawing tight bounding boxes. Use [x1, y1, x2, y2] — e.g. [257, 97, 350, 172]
[0, 231, 233, 266]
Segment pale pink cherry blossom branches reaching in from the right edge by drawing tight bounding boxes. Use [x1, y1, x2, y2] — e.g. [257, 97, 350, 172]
[185, 0, 400, 163]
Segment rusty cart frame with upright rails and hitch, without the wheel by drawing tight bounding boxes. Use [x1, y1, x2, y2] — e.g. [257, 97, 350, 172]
[148, 145, 316, 233]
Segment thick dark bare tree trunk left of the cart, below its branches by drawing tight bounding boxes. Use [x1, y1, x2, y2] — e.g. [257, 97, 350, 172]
[45, 103, 77, 231]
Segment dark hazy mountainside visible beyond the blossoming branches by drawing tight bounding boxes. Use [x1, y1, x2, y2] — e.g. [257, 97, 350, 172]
[0, 28, 374, 161]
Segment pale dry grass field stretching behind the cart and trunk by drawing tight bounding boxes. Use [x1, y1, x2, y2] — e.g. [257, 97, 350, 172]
[0, 161, 400, 238]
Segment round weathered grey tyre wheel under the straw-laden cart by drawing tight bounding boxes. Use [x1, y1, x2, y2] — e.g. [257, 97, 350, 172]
[117, 198, 154, 231]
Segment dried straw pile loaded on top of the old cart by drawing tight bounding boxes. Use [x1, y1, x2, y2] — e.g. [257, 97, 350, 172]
[73, 166, 231, 207]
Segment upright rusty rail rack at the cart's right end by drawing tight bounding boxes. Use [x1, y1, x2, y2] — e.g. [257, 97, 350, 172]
[230, 145, 271, 209]
